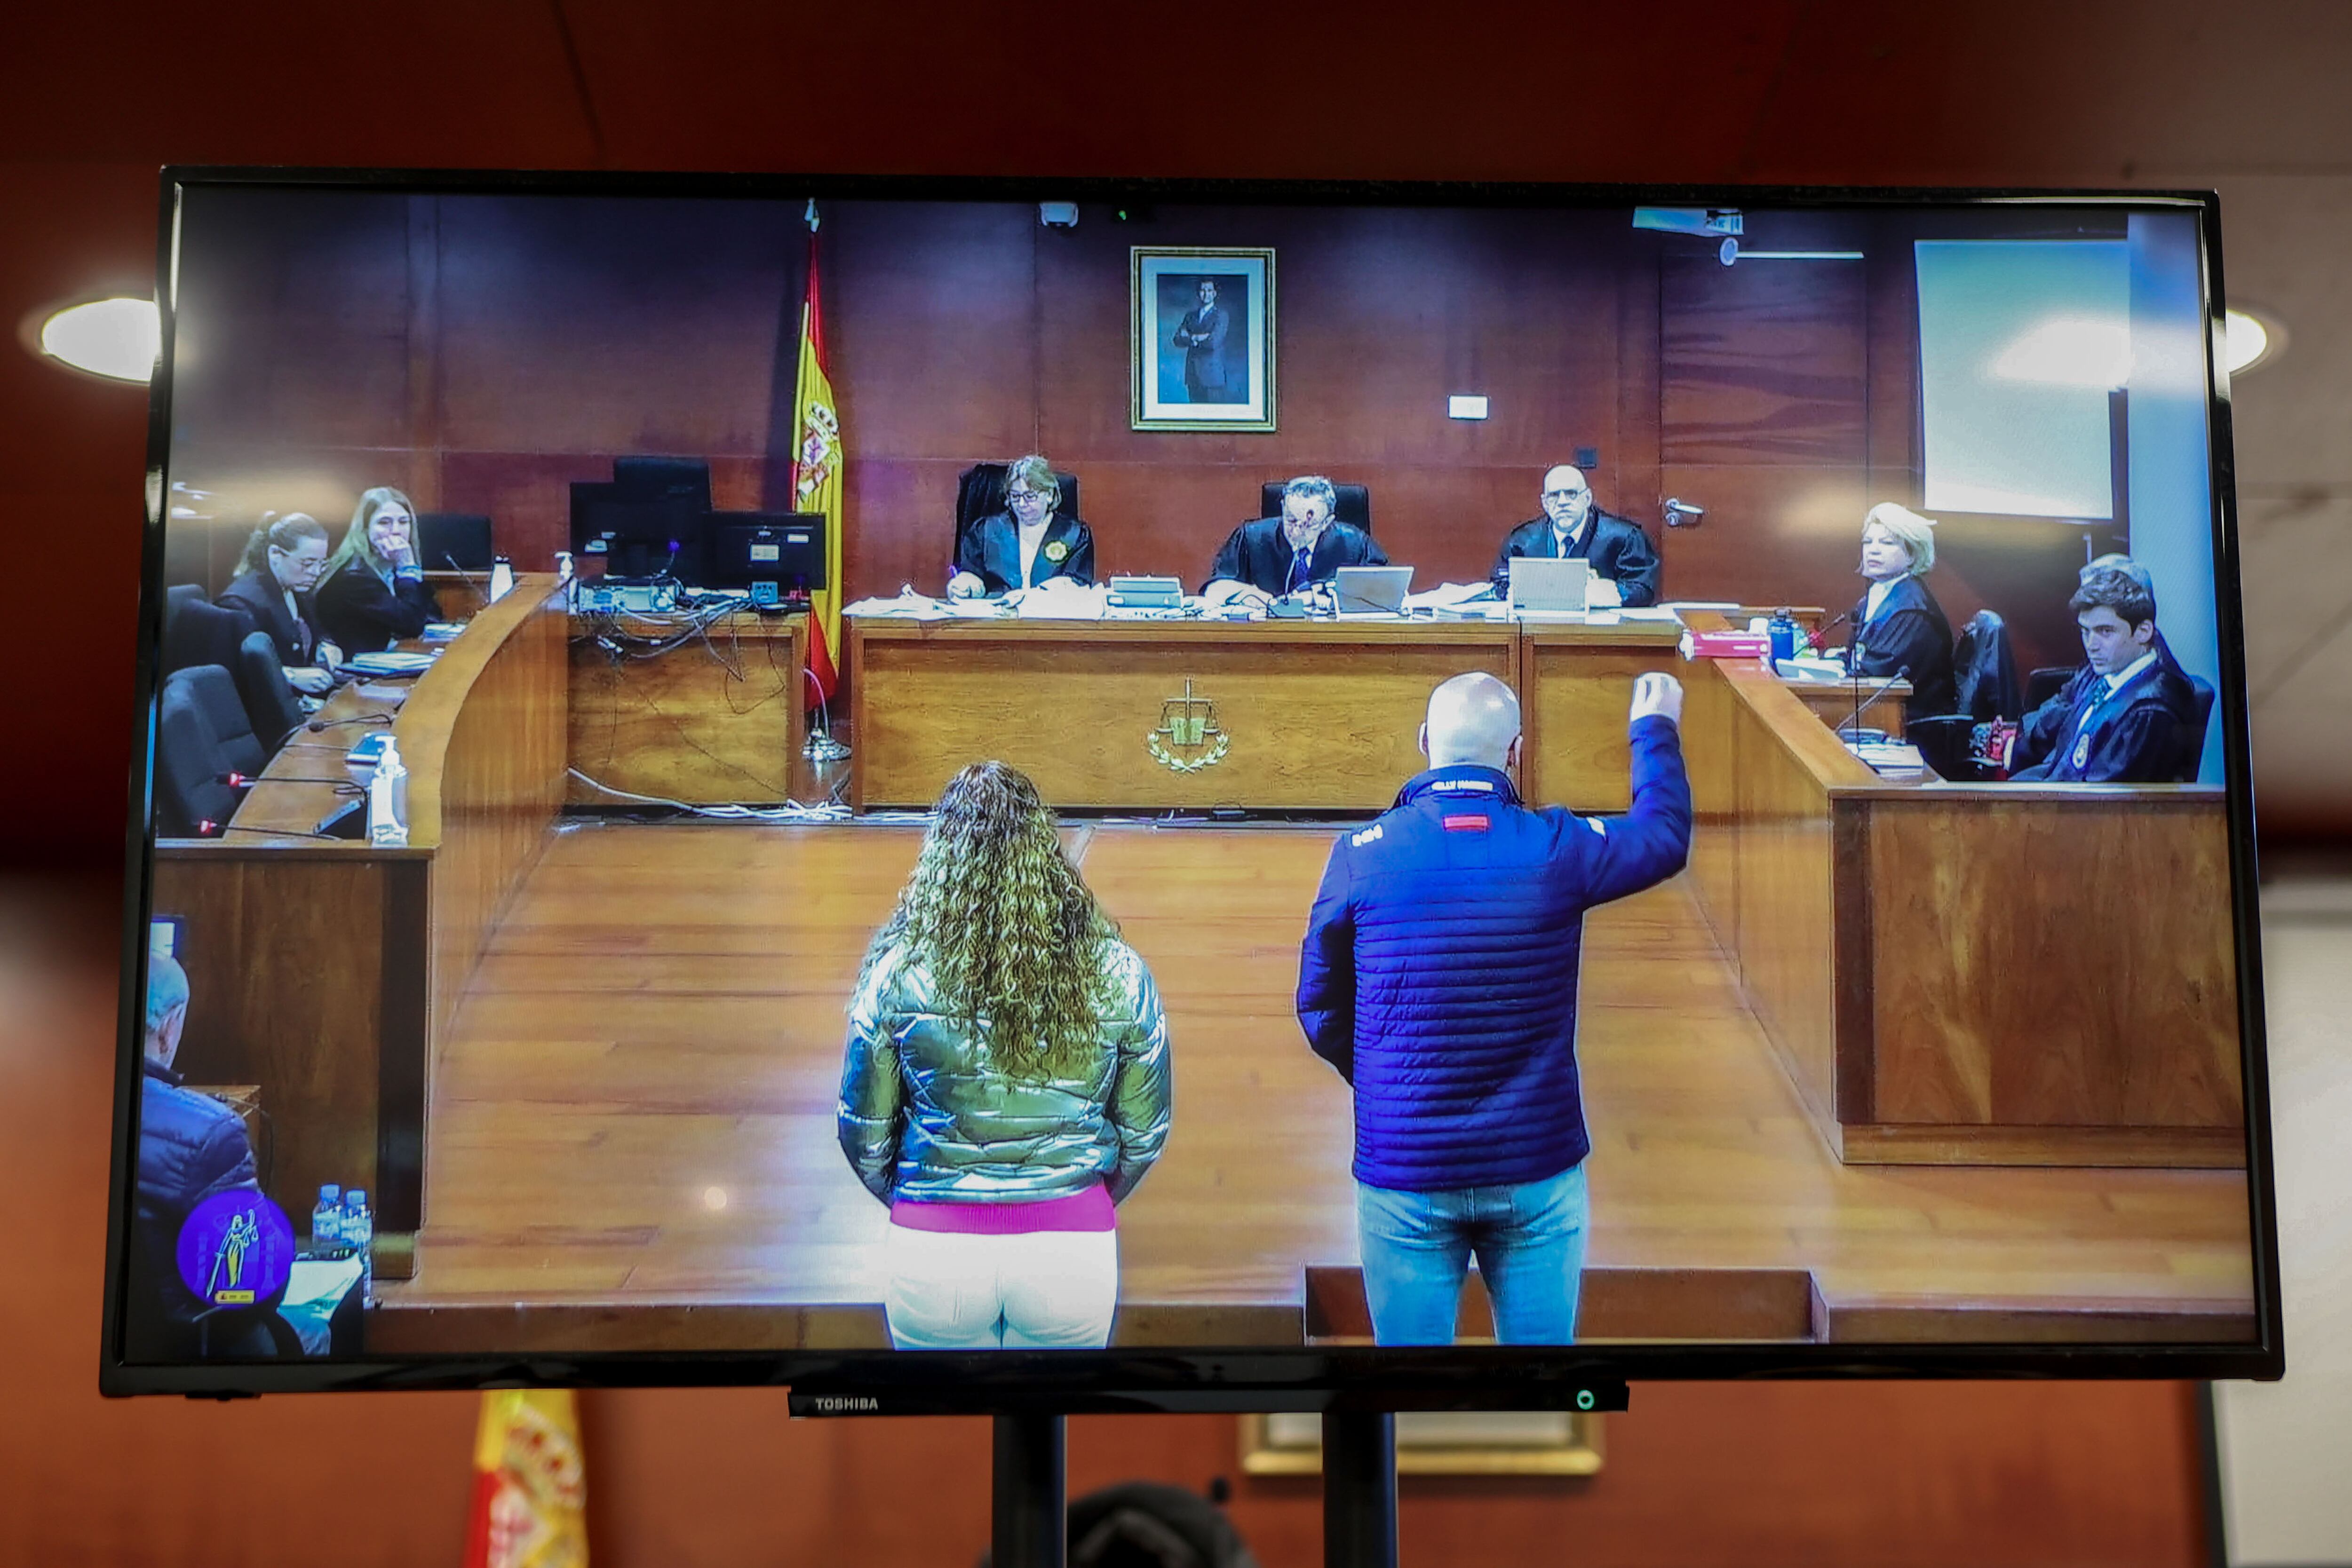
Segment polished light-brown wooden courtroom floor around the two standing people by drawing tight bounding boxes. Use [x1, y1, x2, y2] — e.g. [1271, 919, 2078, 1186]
[372, 825, 2251, 1349]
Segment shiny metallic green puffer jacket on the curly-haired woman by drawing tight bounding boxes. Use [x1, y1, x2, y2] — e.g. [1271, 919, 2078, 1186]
[840, 940, 1174, 1204]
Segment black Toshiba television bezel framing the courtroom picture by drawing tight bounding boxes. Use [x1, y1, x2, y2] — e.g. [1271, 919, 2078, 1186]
[99, 165, 2284, 1415]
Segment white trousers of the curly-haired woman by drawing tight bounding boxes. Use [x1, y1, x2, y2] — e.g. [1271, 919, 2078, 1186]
[882, 1225, 1120, 1349]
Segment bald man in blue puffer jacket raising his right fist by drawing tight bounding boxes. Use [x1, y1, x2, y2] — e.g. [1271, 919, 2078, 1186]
[1298, 675, 1691, 1345]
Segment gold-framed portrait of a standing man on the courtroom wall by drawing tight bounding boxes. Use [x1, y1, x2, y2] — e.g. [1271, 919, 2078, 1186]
[1127, 245, 1275, 430]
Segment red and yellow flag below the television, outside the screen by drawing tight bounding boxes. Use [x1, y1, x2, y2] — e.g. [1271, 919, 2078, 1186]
[466, 1389, 588, 1568]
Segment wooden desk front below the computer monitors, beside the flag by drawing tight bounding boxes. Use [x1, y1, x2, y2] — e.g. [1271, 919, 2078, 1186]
[567, 611, 804, 806]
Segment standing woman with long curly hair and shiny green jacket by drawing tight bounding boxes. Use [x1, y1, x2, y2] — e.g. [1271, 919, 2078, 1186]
[840, 762, 1171, 1349]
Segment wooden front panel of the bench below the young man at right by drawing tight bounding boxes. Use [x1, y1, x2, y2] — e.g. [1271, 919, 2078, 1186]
[1867, 787, 2244, 1135]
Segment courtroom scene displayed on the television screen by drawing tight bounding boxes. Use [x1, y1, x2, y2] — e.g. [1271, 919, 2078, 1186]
[133, 186, 2258, 1363]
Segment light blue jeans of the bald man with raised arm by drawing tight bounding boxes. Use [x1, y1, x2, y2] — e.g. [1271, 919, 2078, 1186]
[1355, 1164, 1592, 1345]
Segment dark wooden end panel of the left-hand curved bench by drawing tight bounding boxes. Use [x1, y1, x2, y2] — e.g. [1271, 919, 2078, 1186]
[153, 844, 395, 1229]
